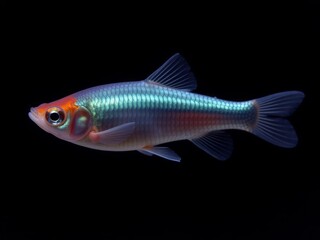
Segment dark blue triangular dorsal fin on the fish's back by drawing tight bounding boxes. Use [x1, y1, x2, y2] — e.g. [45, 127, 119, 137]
[145, 53, 197, 91]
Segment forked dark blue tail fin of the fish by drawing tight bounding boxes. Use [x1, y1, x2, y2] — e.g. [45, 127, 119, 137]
[252, 91, 304, 148]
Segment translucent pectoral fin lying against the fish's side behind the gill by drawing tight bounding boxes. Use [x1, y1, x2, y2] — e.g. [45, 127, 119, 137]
[89, 122, 135, 145]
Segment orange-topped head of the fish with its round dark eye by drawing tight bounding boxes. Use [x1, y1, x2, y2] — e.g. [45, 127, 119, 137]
[29, 96, 92, 142]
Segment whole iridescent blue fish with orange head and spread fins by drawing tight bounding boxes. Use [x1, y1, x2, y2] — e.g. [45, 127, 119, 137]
[28, 53, 304, 162]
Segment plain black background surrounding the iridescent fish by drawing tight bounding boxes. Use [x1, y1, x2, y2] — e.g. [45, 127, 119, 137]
[0, 0, 320, 240]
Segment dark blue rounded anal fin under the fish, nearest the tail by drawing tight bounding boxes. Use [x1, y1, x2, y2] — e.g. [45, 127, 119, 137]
[190, 131, 233, 160]
